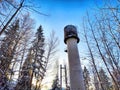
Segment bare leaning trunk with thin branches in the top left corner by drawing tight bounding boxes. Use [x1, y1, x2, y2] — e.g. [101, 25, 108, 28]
[0, 0, 48, 35]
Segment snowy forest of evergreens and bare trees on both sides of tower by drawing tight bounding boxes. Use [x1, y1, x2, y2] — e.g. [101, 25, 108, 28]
[0, 0, 120, 90]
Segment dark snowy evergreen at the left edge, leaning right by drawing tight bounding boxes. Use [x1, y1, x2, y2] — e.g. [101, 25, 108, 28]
[0, 20, 19, 89]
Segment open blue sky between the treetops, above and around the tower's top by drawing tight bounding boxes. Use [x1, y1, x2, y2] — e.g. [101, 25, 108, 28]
[32, 0, 95, 53]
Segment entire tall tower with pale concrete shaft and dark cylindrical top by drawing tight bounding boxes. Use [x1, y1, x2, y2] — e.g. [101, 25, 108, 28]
[64, 25, 85, 90]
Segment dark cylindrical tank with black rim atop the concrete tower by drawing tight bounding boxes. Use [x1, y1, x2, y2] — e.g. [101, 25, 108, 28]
[64, 25, 79, 44]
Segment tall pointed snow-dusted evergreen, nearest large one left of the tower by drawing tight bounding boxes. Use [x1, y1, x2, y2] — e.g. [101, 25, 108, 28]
[33, 25, 46, 90]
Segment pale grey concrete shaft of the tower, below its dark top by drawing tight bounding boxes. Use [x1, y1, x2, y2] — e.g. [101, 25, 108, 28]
[67, 38, 85, 90]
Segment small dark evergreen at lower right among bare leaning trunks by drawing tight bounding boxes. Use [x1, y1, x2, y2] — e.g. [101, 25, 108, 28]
[99, 68, 110, 90]
